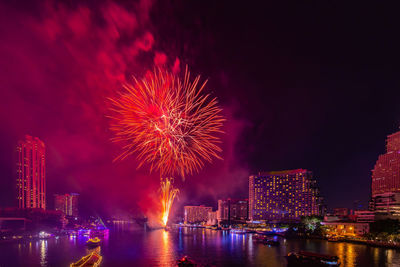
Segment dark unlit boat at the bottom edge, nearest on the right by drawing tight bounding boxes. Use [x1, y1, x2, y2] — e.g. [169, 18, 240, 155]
[286, 251, 340, 266]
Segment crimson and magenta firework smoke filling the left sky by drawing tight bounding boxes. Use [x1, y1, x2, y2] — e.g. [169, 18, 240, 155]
[0, 0, 248, 222]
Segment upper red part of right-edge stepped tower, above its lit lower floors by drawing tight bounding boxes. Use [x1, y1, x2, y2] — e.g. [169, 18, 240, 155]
[372, 131, 400, 197]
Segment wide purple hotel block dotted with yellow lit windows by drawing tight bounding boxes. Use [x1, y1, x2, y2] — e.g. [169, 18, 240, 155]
[249, 169, 322, 224]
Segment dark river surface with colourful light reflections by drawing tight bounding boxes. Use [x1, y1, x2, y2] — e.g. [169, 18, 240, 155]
[0, 228, 400, 267]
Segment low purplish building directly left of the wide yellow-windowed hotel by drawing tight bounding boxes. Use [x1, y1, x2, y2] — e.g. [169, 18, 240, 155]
[217, 199, 249, 222]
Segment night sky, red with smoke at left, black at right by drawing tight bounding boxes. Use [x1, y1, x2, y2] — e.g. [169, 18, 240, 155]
[0, 0, 400, 218]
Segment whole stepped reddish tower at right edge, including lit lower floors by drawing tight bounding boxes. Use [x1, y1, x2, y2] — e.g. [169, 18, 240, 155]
[371, 131, 400, 219]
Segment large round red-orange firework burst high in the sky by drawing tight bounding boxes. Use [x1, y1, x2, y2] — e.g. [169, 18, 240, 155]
[110, 68, 224, 179]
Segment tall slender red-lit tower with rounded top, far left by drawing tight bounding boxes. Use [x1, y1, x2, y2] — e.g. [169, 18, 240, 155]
[16, 135, 46, 209]
